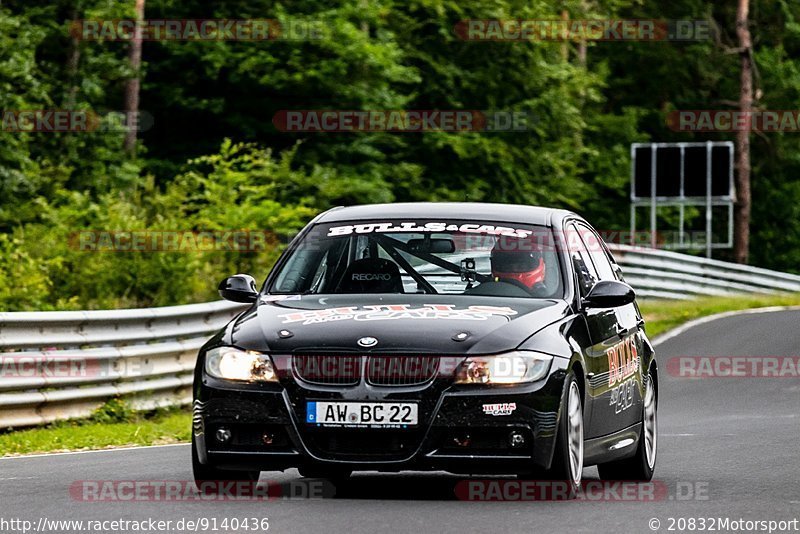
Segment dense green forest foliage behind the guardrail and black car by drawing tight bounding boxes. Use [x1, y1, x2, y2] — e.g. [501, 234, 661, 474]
[0, 0, 800, 310]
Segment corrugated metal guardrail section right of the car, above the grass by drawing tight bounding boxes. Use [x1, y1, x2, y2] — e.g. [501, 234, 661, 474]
[610, 245, 800, 299]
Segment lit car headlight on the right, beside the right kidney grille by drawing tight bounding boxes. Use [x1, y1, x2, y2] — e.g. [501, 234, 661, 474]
[455, 351, 553, 384]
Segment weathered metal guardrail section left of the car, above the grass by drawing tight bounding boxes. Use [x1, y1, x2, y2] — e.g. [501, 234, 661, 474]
[0, 301, 244, 428]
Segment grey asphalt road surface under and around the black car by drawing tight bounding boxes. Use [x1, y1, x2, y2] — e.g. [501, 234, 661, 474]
[0, 311, 800, 534]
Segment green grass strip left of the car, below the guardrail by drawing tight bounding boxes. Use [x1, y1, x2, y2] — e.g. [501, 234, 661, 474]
[0, 410, 192, 456]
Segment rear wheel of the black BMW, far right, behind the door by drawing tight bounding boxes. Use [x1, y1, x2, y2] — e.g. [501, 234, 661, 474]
[597, 374, 658, 482]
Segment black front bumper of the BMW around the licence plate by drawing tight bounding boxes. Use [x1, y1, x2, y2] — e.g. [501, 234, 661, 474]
[193, 360, 566, 474]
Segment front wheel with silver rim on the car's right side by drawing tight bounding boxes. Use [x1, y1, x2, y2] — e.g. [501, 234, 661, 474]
[520, 373, 583, 499]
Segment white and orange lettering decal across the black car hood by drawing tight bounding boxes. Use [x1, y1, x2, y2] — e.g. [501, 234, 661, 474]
[278, 304, 517, 325]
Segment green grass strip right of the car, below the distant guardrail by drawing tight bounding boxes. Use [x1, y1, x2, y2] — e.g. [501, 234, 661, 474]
[639, 294, 800, 339]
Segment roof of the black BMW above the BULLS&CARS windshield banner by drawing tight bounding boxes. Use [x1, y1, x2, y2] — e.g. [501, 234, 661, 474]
[316, 202, 574, 226]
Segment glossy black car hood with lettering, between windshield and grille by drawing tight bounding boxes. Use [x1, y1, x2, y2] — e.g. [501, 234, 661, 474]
[227, 294, 570, 354]
